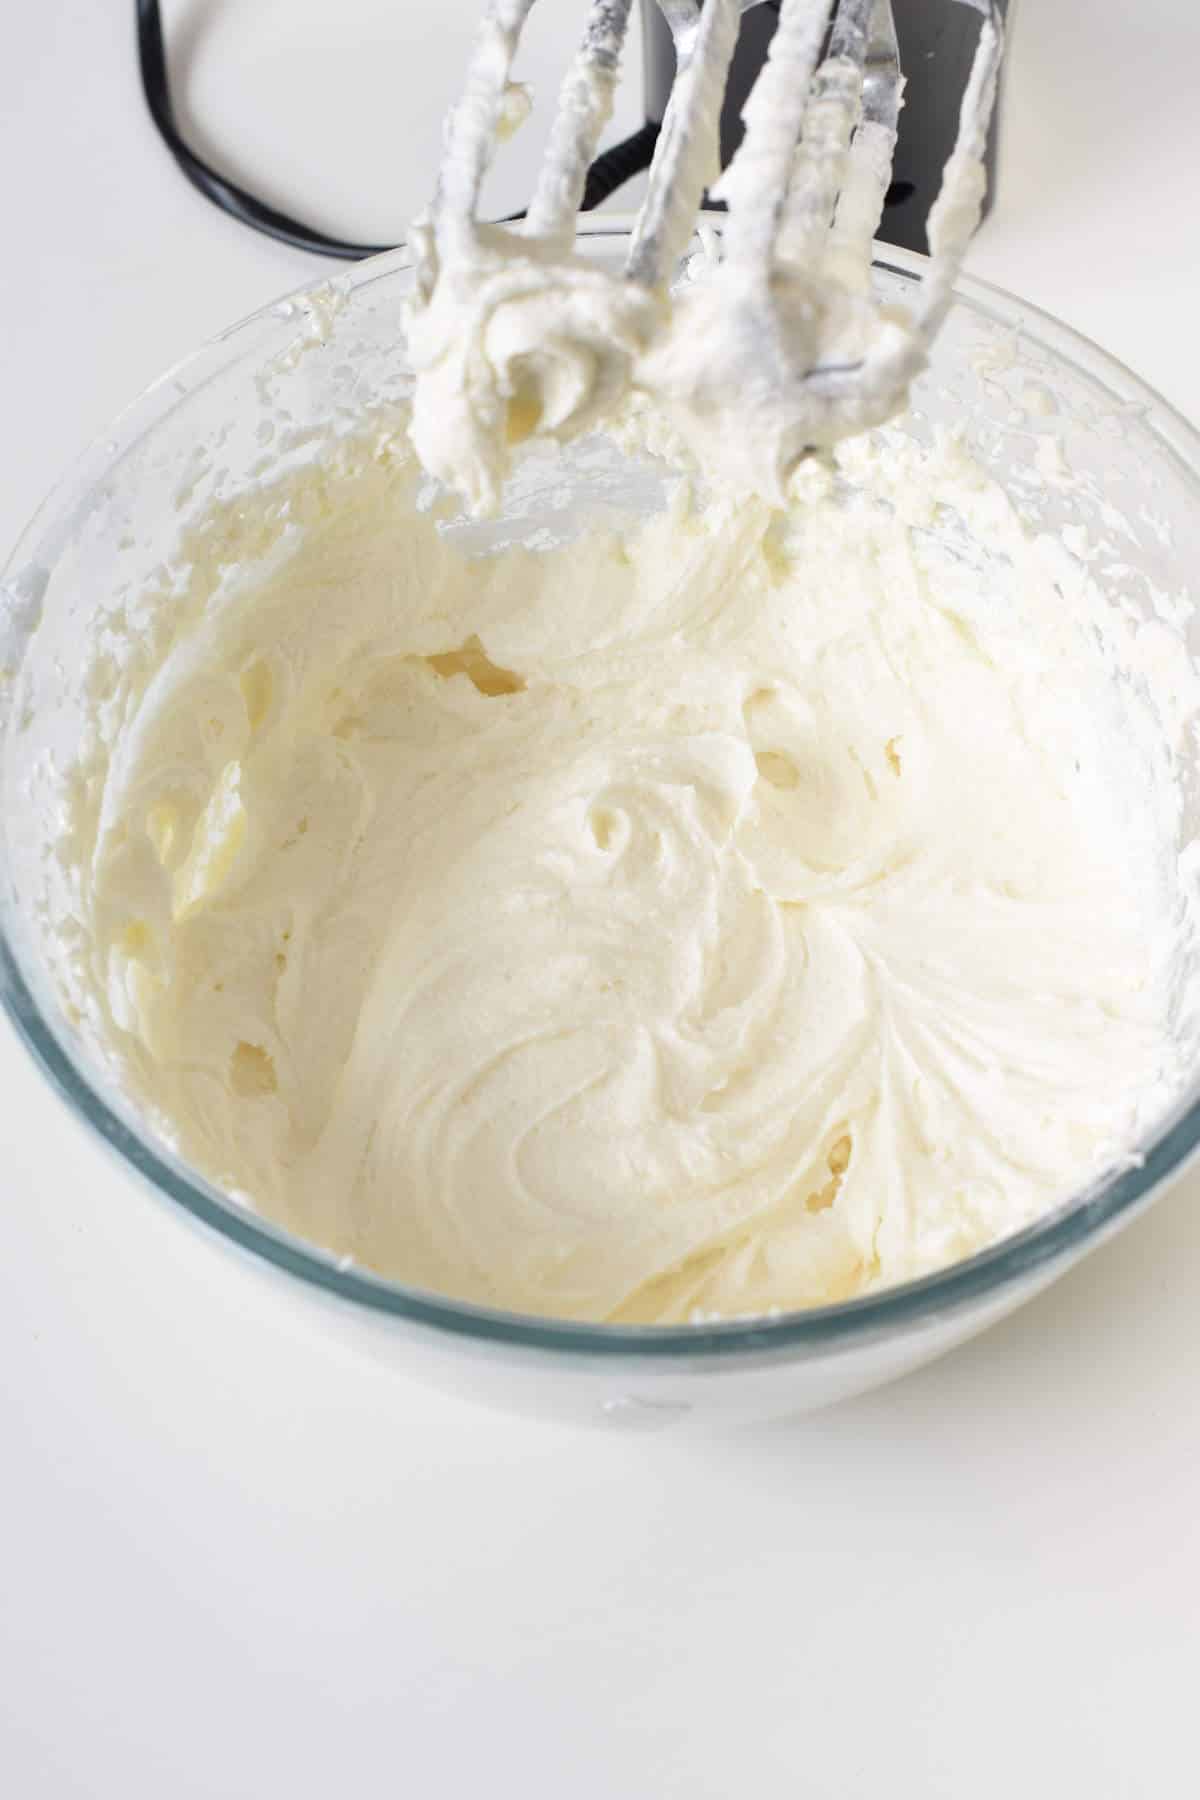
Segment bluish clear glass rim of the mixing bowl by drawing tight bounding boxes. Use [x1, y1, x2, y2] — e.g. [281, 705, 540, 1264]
[0, 214, 1200, 1361]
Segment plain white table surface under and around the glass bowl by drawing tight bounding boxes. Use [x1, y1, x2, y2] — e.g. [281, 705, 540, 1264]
[0, 0, 1200, 1800]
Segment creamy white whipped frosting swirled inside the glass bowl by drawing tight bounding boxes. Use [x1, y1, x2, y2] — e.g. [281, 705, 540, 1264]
[61, 417, 1178, 1321]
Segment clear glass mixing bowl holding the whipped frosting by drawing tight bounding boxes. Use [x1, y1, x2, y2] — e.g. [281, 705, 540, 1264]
[0, 218, 1200, 1426]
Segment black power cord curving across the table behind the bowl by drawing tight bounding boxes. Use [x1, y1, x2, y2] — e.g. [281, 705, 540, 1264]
[135, 0, 658, 263]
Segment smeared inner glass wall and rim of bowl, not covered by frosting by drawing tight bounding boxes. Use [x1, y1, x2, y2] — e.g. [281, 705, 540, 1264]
[0, 221, 1200, 1354]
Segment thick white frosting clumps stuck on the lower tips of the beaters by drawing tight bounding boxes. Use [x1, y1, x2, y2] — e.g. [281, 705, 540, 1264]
[408, 227, 925, 515]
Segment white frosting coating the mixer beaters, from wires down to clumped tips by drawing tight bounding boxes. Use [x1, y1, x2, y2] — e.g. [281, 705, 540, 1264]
[408, 0, 1000, 513]
